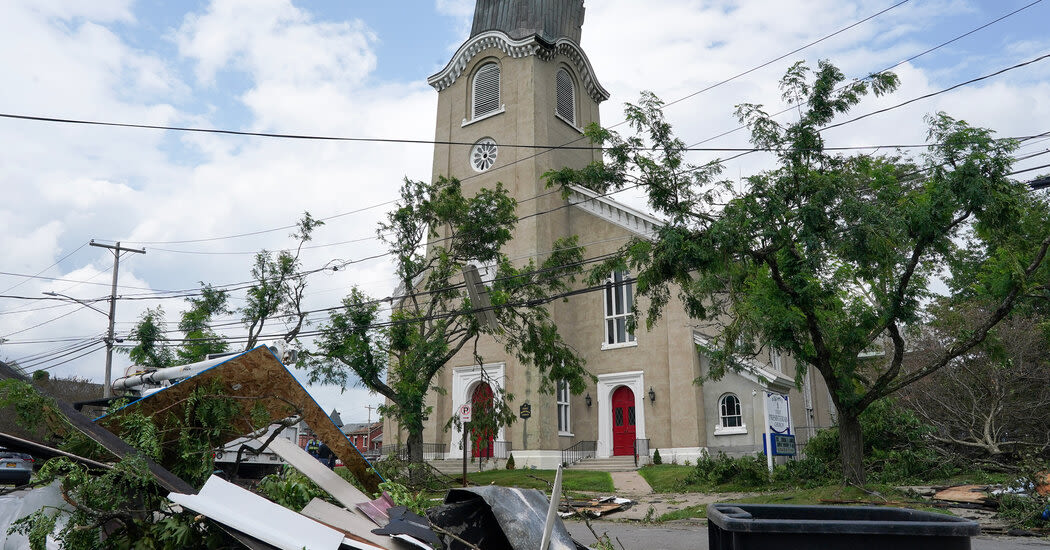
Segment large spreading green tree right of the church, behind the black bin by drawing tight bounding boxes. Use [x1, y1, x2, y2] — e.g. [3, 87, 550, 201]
[548, 57, 1050, 484]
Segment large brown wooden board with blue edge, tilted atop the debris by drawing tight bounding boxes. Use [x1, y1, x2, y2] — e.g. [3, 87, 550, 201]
[97, 345, 382, 492]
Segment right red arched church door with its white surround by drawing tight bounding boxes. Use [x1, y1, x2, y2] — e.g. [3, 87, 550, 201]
[596, 371, 646, 459]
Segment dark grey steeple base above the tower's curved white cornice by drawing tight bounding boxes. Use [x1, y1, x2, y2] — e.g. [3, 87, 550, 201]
[470, 0, 584, 44]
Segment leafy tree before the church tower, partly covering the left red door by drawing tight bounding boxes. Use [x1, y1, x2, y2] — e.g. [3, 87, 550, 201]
[306, 177, 586, 462]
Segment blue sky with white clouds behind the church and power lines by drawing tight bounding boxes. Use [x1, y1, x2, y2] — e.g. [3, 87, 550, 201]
[0, 0, 1050, 421]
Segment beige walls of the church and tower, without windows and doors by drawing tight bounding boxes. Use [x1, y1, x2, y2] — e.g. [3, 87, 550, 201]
[386, 0, 831, 468]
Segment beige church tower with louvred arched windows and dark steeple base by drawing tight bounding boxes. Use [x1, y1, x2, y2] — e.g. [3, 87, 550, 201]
[427, 0, 609, 263]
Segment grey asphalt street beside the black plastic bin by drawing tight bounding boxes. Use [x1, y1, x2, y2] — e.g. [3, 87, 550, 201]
[565, 521, 1050, 550]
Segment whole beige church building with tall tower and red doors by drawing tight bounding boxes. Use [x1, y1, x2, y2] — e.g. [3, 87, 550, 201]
[385, 0, 832, 468]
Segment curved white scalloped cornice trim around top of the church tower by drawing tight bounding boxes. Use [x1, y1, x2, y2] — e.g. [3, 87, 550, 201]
[426, 30, 609, 103]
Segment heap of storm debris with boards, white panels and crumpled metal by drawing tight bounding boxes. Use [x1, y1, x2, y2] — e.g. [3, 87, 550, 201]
[0, 346, 592, 550]
